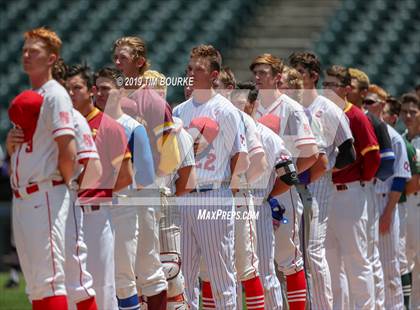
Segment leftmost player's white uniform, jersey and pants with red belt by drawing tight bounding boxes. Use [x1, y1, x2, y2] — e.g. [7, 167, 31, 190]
[11, 80, 75, 300]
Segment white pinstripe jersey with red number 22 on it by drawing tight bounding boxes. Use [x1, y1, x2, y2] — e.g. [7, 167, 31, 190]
[173, 94, 247, 185]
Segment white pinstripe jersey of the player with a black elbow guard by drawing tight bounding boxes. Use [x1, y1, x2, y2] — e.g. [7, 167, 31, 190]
[252, 123, 291, 198]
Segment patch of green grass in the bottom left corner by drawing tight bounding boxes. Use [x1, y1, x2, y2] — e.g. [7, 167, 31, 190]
[0, 272, 31, 310]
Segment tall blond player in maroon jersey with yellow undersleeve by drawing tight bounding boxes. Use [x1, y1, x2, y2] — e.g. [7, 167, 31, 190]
[113, 37, 180, 308]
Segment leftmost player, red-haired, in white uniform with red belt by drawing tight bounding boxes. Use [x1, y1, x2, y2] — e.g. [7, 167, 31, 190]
[7, 28, 76, 310]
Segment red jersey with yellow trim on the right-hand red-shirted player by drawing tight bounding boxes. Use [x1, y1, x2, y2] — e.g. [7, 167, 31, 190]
[333, 103, 380, 184]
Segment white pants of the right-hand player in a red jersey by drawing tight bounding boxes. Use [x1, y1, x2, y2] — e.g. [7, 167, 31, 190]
[326, 182, 374, 309]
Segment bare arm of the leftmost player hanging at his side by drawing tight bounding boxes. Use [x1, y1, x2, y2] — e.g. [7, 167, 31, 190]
[55, 135, 76, 184]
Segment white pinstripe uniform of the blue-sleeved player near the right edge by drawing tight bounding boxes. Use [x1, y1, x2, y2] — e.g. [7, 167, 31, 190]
[375, 125, 411, 309]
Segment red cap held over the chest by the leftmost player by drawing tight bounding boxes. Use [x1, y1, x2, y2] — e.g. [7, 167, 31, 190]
[8, 90, 44, 142]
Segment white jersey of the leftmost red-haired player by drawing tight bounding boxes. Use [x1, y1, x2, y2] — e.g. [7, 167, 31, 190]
[11, 80, 75, 189]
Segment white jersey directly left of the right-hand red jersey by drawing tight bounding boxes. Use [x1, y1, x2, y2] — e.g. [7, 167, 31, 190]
[308, 96, 353, 169]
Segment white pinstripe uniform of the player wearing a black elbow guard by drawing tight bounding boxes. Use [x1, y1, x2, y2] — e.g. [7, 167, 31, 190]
[251, 123, 291, 309]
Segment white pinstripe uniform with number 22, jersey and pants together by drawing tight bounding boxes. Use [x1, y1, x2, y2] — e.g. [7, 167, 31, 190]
[174, 94, 247, 309]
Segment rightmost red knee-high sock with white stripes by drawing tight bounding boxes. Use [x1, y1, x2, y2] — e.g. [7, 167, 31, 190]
[286, 269, 306, 310]
